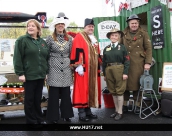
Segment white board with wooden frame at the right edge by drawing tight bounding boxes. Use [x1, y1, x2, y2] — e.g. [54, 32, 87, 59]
[161, 62, 172, 91]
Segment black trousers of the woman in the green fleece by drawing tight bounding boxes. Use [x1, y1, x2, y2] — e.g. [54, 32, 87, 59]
[24, 79, 44, 124]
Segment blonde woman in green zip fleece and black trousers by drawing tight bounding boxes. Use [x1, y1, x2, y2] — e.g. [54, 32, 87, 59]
[13, 19, 49, 124]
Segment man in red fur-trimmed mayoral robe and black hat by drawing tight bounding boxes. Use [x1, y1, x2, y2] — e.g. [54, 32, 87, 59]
[71, 18, 102, 121]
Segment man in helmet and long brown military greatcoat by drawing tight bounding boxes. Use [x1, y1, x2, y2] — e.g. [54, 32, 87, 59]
[121, 14, 152, 112]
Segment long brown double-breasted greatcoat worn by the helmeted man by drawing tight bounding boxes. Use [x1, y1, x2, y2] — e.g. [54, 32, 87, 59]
[121, 27, 152, 91]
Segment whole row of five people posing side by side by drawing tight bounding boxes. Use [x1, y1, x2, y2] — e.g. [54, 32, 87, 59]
[13, 12, 152, 124]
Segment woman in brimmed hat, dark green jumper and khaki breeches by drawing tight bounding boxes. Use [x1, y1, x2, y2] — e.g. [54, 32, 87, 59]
[103, 29, 130, 120]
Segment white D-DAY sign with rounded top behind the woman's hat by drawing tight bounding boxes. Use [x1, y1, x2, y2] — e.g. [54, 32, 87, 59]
[98, 20, 120, 55]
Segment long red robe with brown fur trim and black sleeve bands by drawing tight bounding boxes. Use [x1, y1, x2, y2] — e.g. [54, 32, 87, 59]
[70, 32, 102, 108]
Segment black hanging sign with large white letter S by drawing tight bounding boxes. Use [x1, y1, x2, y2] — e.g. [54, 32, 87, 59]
[151, 5, 164, 49]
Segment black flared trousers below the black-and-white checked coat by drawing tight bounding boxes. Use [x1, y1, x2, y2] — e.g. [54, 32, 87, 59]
[47, 86, 74, 121]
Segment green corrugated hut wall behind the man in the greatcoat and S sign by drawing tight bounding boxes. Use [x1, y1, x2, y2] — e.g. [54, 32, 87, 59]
[93, 0, 172, 94]
